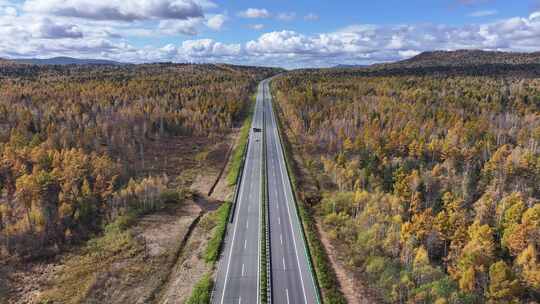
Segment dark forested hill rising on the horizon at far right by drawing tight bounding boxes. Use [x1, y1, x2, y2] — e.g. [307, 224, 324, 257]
[376, 50, 540, 68]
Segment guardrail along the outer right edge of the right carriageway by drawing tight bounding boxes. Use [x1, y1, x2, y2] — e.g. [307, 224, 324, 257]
[270, 80, 322, 304]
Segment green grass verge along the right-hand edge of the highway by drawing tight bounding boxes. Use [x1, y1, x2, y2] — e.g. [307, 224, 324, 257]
[273, 82, 347, 304]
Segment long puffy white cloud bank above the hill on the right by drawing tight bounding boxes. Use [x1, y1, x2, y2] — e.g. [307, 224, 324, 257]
[245, 12, 540, 66]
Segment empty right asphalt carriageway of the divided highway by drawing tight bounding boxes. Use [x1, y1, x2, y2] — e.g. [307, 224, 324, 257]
[262, 80, 317, 304]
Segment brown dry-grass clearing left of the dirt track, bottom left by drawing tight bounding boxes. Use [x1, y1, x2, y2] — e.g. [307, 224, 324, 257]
[2, 201, 201, 304]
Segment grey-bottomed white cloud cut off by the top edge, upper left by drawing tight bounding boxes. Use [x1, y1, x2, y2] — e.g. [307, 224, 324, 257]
[23, 0, 203, 21]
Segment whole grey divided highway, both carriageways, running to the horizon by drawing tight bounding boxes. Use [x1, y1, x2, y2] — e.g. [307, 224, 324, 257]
[212, 79, 318, 304]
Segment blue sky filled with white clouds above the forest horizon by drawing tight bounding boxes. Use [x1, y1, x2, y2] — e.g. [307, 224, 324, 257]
[0, 0, 540, 68]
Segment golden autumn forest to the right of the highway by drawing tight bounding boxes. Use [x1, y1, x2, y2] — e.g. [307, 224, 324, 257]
[273, 65, 540, 304]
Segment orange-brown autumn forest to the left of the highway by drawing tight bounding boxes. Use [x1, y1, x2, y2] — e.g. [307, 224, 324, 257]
[0, 64, 275, 261]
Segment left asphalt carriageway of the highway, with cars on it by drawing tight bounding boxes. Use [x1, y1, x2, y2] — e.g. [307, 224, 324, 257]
[212, 79, 264, 304]
